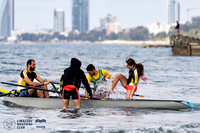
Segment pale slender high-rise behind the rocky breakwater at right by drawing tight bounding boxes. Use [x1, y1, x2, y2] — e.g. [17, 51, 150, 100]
[168, 0, 180, 24]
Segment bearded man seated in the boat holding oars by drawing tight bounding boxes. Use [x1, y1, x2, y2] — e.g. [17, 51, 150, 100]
[17, 59, 50, 98]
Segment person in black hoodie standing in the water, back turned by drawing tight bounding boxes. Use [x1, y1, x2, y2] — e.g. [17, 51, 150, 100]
[60, 58, 92, 109]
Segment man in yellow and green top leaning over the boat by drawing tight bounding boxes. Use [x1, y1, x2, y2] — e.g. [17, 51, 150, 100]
[85, 64, 112, 96]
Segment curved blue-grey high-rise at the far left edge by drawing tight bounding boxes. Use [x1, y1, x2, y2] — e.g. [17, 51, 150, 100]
[0, 0, 14, 37]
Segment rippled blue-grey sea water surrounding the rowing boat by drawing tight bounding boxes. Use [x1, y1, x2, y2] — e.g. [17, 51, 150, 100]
[0, 44, 200, 133]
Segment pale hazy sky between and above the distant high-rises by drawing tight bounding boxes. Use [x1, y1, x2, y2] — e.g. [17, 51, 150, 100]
[15, 0, 200, 30]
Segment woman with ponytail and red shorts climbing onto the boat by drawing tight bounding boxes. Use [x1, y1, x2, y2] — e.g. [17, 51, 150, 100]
[111, 58, 147, 99]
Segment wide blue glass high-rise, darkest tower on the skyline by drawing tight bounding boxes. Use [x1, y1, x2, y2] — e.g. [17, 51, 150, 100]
[72, 0, 89, 32]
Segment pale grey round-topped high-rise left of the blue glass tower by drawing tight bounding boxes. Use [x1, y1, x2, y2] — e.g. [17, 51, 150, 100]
[54, 8, 65, 32]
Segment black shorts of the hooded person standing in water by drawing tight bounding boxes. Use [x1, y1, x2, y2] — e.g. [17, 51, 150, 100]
[63, 89, 80, 99]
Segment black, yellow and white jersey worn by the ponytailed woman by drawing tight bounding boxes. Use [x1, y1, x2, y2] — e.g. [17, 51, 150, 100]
[127, 69, 140, 85]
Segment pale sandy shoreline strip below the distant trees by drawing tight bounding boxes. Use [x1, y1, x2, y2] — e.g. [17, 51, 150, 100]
[0, 40, 169, 45]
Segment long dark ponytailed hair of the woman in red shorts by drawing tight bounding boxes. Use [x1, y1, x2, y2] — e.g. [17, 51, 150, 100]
[126, 58, 144, 76]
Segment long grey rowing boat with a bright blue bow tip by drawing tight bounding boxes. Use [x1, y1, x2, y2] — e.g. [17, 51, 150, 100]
[3, 96, 194, 110]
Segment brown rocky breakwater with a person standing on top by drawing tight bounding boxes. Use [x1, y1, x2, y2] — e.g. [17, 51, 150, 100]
[170, 35, 200, 56]
